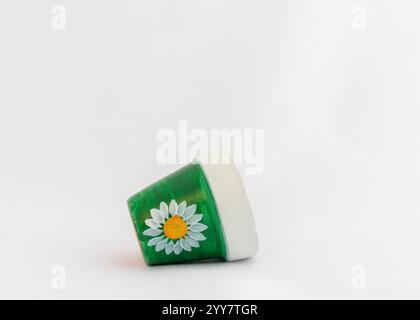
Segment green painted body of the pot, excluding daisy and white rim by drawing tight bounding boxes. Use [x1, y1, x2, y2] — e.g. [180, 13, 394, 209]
[128, 164, 226, 265]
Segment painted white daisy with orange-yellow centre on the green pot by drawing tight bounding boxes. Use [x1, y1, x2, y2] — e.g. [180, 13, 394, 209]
[143, 200, 208, 255]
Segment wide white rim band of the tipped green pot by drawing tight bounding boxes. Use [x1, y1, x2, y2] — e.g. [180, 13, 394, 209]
[200, 163, 258, 261]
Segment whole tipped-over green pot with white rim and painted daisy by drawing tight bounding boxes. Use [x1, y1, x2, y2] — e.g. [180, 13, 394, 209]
[128, 163, 258, 265]
